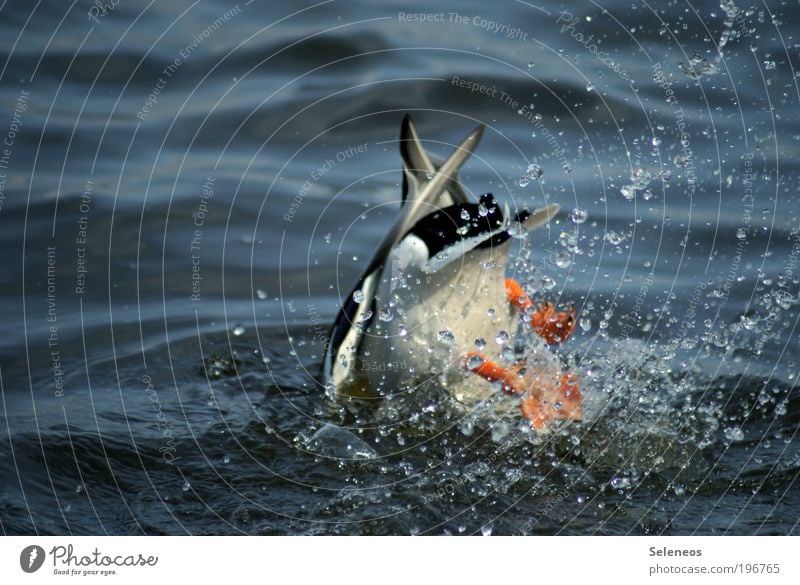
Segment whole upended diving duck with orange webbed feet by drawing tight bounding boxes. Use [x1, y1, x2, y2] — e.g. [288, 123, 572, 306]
[322, 115, 582, 431]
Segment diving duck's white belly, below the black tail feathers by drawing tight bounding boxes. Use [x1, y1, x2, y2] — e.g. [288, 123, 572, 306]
[357, 249, 518, 401]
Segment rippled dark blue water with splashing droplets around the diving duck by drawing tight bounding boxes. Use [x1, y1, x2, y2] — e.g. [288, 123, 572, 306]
[0, 0, 800, 534]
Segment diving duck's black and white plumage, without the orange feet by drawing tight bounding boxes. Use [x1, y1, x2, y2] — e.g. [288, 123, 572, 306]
[323, 116, 558, 399]
